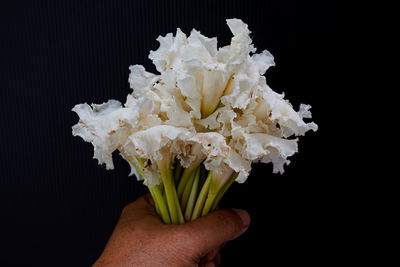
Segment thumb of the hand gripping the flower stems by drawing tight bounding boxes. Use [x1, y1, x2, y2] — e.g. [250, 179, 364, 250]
[184, 209, 250, 256]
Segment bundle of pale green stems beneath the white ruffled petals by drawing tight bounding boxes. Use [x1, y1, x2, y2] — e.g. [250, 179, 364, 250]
[126, 153, 237, 224]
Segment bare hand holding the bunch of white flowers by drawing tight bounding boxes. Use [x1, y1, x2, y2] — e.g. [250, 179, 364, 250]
[93, 194, 250, 267]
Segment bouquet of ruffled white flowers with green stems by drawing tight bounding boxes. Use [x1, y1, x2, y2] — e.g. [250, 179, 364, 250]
[72, 19, 317, 224]
